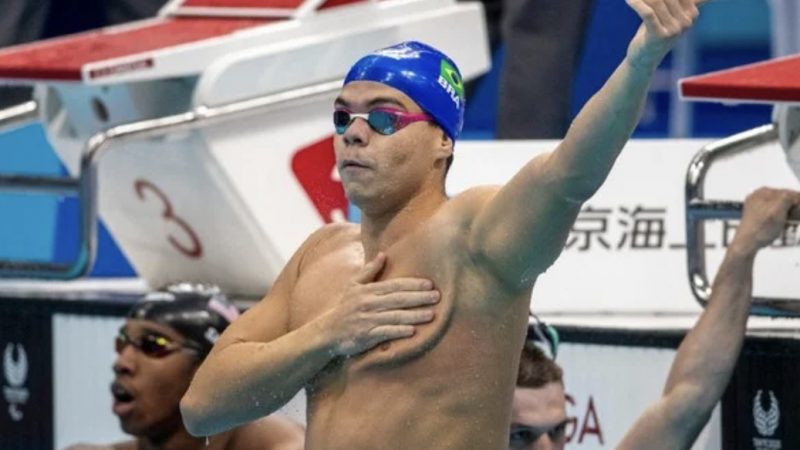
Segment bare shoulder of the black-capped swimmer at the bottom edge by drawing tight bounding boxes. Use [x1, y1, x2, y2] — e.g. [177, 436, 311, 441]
[231, 414, 305, 450]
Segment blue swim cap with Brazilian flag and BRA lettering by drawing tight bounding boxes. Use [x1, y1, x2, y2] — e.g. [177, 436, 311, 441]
[344, 41, 465, 142]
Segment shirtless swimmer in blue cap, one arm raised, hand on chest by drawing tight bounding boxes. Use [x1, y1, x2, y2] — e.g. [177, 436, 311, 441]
[181, 4, 708, 450]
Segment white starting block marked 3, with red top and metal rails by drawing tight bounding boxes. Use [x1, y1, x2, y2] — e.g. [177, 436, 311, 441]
[0, 0, 489, 297]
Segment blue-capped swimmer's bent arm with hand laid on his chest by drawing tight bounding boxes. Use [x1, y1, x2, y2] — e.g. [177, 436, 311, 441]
[181, 229, 438, 436]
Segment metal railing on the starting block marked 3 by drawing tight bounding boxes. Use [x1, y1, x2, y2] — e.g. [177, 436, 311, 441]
[0, 80, 342, 279]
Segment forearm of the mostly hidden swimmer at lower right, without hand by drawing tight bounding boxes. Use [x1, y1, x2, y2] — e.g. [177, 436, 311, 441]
[664, 241, 756, 417]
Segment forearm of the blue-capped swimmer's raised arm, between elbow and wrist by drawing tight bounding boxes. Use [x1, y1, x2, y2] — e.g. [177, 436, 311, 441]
[550, 41, 657, 202]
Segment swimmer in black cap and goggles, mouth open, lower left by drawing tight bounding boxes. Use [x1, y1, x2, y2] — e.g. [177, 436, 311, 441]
[62, 283, 303, 450]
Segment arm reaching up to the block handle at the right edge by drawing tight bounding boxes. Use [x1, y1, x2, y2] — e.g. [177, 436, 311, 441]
[617, 189, 800, 450]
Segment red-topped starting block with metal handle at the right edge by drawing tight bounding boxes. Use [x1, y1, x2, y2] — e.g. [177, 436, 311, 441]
[679, 55, 800, 316]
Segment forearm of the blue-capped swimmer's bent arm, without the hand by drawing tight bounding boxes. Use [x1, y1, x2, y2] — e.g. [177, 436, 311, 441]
[181, 322, 332, 436]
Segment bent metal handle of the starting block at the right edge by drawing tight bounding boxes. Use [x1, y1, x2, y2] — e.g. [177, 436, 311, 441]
[685, 123, 800, 317]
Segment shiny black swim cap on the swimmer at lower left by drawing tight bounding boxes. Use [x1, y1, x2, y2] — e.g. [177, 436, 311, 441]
[128, 283, 239, 358]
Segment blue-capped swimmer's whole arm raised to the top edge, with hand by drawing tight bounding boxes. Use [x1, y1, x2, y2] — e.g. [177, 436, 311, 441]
[470, 0, 700, 288]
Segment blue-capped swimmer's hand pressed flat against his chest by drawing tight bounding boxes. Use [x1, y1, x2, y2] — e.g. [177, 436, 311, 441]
[322, 253, 439, 356]
